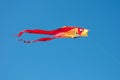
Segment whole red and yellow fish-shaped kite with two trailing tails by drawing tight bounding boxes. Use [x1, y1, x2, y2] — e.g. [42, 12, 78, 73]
[17, 26, 89, 43]
